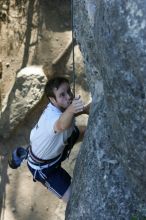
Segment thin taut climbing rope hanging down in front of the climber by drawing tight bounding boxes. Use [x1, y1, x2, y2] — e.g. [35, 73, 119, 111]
[71, 0, 76, 97]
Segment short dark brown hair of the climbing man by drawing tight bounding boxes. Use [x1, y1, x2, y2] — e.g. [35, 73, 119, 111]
[44, 77, 69, 99]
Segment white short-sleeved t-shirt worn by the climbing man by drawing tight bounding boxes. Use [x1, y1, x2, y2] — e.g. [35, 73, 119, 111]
[30, 103, 74, 160]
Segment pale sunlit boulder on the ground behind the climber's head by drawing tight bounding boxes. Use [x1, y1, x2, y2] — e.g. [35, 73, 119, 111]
[0, 66, 47, 138]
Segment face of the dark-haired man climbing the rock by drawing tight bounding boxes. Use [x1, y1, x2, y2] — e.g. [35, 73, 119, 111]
[51, 83, 73, 111]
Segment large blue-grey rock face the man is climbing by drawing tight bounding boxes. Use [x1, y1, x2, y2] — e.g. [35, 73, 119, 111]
[66, 0, 146, 220]
